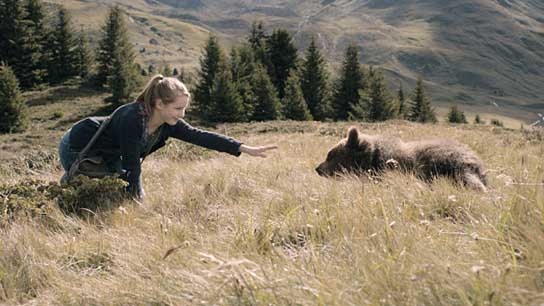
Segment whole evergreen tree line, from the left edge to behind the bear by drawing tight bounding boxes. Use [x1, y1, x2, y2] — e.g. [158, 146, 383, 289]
[0, 0, 482, 132]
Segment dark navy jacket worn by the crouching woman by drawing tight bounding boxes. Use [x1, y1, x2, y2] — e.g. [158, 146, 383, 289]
[70, 102, 242, 189]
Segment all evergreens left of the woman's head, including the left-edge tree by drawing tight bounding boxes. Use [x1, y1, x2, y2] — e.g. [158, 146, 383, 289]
[0, 0, 141, 132]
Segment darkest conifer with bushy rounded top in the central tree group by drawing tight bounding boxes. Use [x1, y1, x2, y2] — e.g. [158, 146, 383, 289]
[266, 29, 298, 99]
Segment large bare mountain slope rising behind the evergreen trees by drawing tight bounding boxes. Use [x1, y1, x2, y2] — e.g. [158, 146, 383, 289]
[53, 0, 544, 121]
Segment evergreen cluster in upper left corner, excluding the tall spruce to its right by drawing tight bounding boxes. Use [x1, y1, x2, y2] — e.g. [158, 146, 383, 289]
[0, 0, 92, 90]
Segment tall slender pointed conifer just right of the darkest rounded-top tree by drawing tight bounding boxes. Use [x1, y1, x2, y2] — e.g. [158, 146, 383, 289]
[300, 37, 331, 120]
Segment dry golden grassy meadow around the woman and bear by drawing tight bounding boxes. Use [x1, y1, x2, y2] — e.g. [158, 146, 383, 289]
[0, 86, 544, 305]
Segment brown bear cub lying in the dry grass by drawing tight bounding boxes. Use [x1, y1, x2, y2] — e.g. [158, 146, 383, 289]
[315, 127, 487, 192]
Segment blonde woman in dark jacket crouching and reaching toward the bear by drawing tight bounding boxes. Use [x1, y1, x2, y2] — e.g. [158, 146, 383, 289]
[59, 75, 277, 199]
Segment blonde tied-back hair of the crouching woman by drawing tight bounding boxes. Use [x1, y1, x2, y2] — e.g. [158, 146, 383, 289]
[136, 74, 191, 116]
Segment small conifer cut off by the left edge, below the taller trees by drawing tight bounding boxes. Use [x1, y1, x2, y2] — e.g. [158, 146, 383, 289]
[0, 65, 27, 133]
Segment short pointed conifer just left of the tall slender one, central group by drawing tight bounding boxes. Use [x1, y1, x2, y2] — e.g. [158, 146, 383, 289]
[282, 69, 313, 121]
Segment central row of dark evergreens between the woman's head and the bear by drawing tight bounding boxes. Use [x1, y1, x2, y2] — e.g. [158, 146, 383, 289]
[189, 22, 436, 122]
